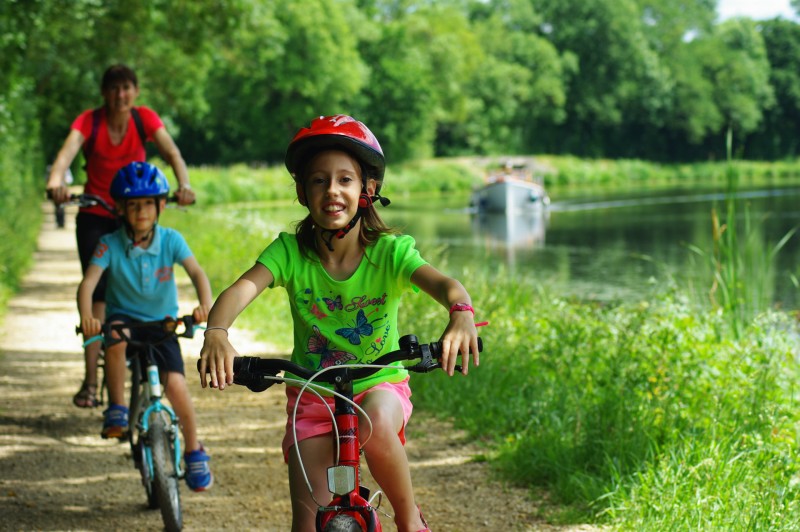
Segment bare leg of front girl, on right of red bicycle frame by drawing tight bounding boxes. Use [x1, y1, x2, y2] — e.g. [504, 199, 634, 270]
[358, 390, 425, 532]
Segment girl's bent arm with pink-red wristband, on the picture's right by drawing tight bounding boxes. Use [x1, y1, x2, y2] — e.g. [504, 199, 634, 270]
[411, 264, 480, 376]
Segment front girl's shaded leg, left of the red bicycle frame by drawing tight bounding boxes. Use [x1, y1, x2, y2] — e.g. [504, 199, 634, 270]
[289, 434, 333, 532]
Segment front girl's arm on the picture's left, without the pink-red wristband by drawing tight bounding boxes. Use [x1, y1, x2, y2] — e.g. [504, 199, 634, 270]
[200, 263, 275, 390]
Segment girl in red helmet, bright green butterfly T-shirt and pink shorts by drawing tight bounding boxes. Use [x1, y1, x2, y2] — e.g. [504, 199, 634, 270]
[200, 115, 478, 531]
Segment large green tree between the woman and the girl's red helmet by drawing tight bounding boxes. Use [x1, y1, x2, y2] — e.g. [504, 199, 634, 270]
[180, 0, 368, 163]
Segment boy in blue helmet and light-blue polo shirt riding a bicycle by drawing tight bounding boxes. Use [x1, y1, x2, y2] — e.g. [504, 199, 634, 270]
[78, 162, 213, 491]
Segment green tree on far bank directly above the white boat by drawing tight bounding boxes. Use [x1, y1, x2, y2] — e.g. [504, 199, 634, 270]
[438, 0, 572, 154]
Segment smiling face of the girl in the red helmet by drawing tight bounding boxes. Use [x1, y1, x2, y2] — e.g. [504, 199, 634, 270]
[297, 150, 375, 230]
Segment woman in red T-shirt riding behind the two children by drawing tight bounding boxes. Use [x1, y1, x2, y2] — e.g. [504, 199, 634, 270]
[47, 65, 194, 408]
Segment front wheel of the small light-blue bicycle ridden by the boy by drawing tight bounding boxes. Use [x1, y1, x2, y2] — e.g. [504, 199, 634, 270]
[148, 415, 183, 532]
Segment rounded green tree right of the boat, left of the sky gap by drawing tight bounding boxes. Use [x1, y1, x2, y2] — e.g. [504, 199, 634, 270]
[532, 0, 672, 155]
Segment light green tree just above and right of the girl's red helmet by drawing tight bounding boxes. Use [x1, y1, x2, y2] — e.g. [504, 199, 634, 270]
[362, 5, 481, 160]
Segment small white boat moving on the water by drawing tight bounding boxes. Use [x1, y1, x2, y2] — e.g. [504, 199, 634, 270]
[470, 165, 550, 213]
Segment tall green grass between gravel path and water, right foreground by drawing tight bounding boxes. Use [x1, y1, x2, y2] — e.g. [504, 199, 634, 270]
[409, 277, 800, 530]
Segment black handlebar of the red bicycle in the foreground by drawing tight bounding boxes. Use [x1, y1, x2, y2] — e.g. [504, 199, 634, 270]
[197, 334, 483, 392]
